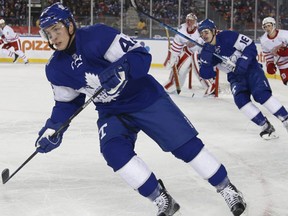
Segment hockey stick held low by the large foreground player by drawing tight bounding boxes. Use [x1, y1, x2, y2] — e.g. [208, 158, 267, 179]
[2, 87, 104, 184]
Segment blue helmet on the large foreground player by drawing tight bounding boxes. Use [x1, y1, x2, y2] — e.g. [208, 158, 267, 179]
[40, 2, 75, 29]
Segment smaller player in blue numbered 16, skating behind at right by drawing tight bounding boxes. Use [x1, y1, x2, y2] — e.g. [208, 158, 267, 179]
[198, 19, 288, 140]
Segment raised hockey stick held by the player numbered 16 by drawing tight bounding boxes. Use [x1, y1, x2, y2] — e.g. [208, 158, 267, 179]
[130, 0, 236, 68]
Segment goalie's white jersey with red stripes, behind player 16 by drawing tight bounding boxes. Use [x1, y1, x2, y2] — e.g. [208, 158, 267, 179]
[170, 23, 204, 56]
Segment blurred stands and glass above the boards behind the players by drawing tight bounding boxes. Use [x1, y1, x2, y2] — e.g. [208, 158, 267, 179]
[0, 0, 288, 42]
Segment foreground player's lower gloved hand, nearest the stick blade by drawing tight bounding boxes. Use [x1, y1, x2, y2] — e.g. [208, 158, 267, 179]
[35, 119, 67, 153]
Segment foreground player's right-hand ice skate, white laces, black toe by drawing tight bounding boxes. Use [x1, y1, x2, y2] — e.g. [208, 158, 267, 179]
[218, 183, 246, 216]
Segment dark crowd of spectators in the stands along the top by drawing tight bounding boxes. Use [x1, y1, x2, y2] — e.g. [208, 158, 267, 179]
[0, 0, 288, 33]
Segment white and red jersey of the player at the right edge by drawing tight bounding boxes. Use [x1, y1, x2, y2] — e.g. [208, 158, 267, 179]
[260, 29, 288, 69]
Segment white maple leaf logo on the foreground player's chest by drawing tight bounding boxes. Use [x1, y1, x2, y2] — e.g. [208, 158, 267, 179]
[79, 72, 119, 103]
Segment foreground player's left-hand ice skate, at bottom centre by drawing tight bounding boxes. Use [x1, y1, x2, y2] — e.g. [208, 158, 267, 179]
[153, 179, 180, 216]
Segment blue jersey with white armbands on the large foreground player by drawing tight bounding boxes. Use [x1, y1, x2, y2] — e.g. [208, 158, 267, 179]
[46, 24, 165, 122]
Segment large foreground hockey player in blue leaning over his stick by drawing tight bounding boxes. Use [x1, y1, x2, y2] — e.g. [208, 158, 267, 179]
[35, 3, 246, 216]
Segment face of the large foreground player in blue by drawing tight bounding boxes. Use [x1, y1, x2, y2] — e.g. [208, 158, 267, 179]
[44, 22, 70, 50]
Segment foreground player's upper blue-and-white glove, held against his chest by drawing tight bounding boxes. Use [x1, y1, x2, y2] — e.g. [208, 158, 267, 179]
[98, 60, 129, 95]
